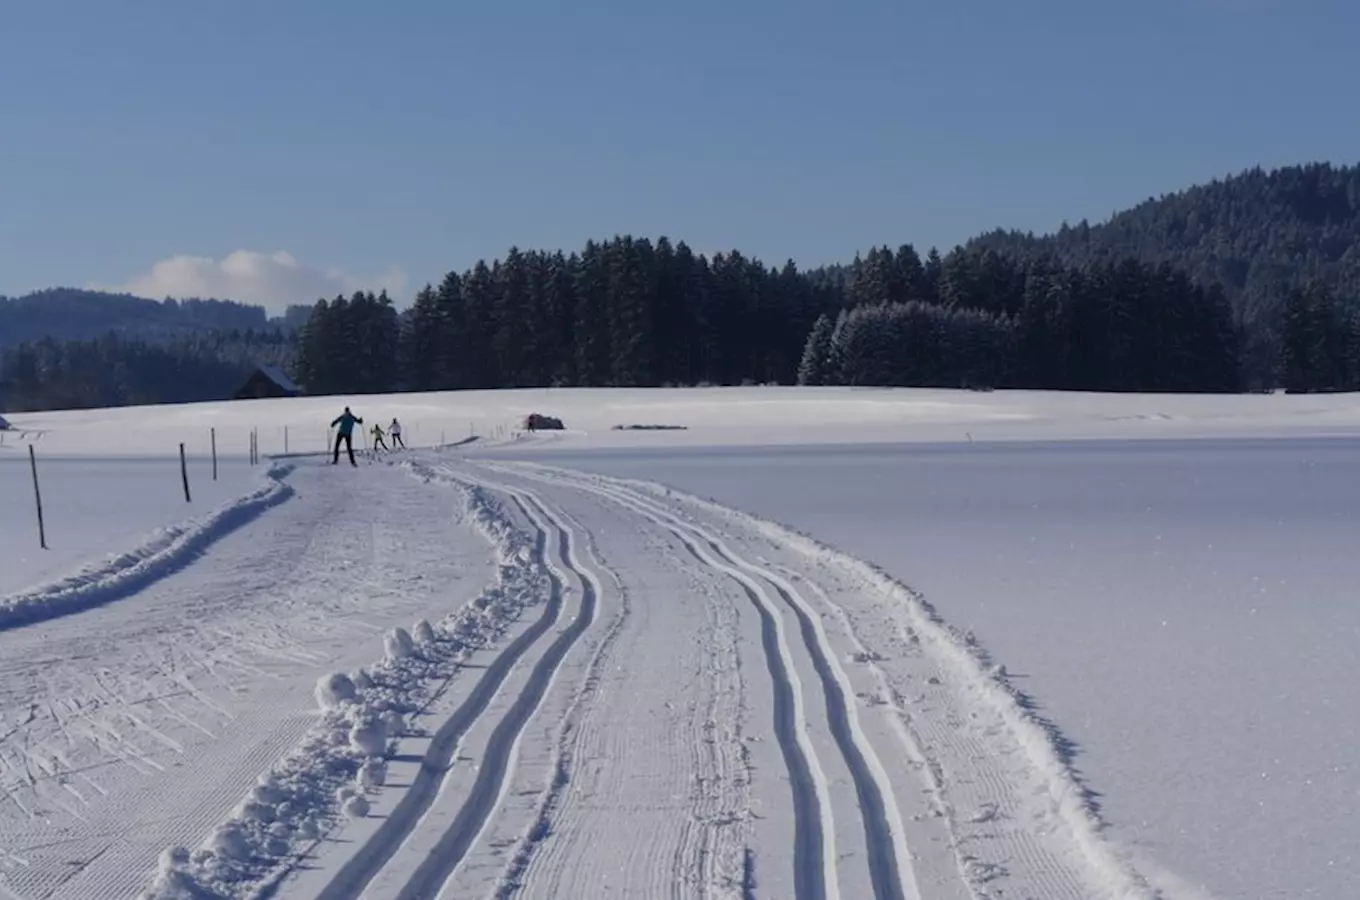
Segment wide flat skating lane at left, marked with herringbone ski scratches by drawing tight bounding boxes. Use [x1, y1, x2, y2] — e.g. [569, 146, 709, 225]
[0, 465, 488, 900]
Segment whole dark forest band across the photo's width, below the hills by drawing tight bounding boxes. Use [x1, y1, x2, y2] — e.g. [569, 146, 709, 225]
[0, 237, 1360, 418]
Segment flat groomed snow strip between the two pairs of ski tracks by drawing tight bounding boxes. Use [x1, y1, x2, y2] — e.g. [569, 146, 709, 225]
[446, 469, 761, 900]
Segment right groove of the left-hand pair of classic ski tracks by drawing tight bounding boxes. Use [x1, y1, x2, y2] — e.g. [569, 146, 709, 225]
[378, 483, 597, 900]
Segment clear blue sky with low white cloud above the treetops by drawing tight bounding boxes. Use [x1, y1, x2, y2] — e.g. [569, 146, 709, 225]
[0, 0, 1360, 314]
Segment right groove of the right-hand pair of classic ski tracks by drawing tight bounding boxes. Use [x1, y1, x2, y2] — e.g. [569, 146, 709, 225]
[489, 462, 922, 900]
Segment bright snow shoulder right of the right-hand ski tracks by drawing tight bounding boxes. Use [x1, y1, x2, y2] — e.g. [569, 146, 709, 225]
[479, 461, 1161, 900]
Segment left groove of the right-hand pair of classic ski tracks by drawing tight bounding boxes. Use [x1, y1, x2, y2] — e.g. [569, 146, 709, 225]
[487, 465, 837, 900]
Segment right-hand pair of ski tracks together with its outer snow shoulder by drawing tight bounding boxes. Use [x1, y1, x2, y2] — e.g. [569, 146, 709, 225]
[483, 462, 1160, 900]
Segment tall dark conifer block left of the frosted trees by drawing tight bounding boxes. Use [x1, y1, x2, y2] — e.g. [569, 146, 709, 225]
[296, 237, 839, 393]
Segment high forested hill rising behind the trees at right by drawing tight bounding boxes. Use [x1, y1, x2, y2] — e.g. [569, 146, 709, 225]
[967, 163, 1360, 381]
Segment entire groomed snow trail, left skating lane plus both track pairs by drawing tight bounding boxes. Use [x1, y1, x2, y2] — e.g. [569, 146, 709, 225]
[18, 455, 1180, 900]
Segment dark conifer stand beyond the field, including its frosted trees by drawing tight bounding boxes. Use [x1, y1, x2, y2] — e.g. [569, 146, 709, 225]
[296, 237, 1240, 393]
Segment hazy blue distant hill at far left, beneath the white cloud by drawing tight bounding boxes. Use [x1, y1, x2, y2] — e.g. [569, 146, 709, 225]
[0, 288, 310, 349]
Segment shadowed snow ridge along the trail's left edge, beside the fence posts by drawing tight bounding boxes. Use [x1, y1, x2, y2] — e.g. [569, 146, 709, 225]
[0, 465, 292, 629]
